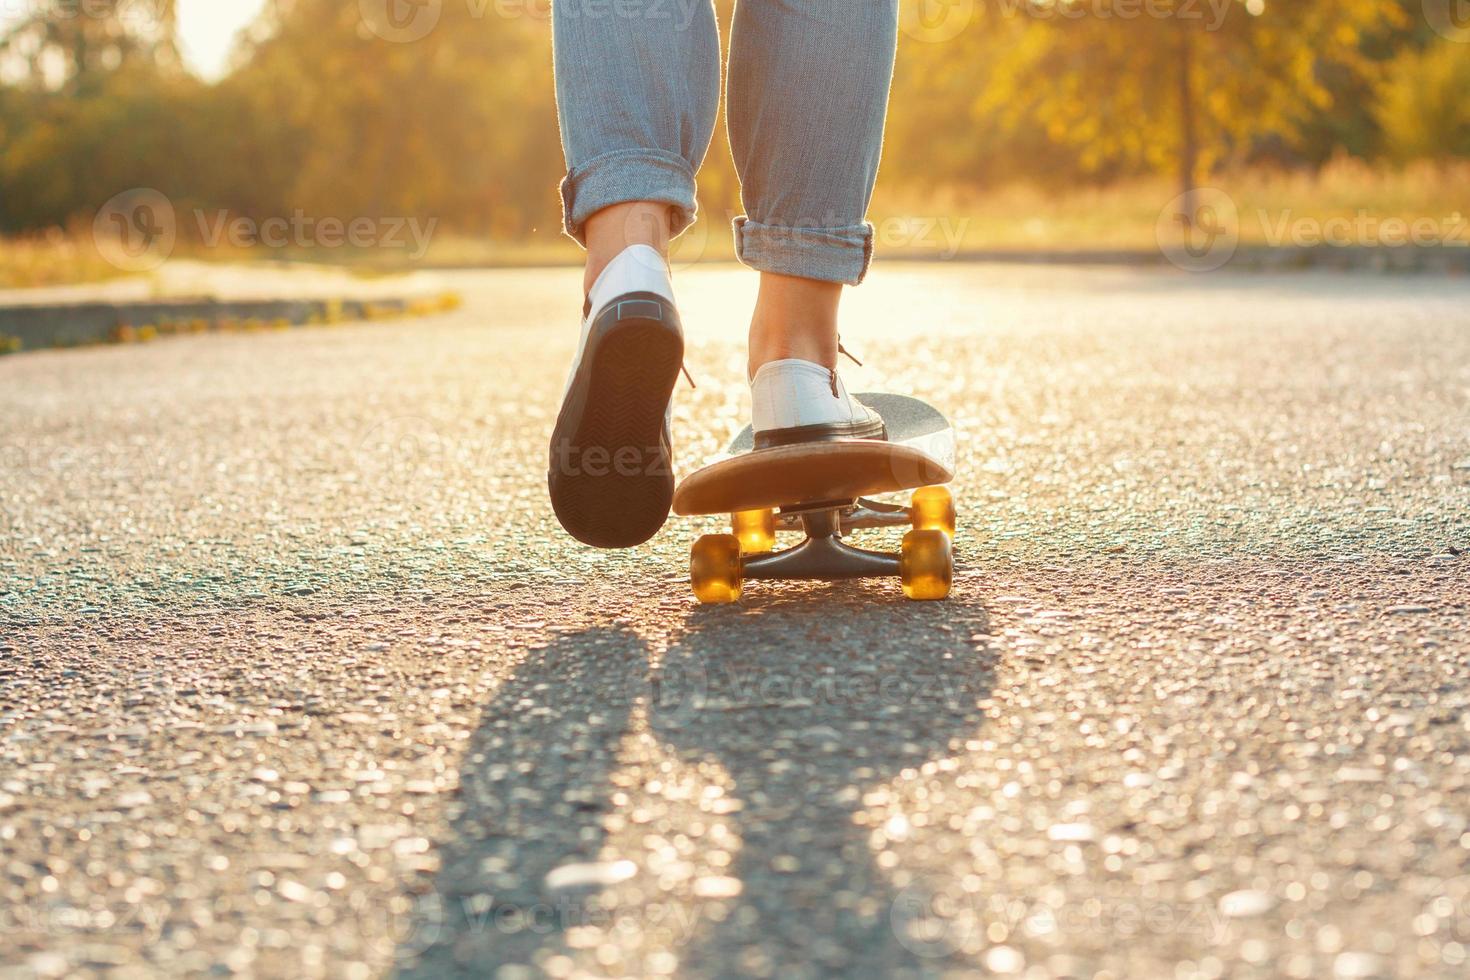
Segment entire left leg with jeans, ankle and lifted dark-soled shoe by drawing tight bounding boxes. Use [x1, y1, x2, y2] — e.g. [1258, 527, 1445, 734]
[547, 0, 720, 548]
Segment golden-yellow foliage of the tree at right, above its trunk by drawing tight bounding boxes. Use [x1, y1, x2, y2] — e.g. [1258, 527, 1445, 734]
[961, 0, 1402, 215]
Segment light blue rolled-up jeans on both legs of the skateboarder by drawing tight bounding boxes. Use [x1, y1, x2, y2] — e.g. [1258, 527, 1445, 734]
[551, 0, 898, 285]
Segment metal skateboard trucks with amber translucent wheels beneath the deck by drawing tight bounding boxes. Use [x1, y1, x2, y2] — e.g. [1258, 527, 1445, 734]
[689, 486, 954, 604]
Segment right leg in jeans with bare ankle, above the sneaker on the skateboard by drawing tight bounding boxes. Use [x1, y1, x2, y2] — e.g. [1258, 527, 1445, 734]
[726, 0, 898, 375]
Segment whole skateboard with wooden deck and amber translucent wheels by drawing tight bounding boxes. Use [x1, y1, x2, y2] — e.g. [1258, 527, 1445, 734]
[673, 392, 956, 604]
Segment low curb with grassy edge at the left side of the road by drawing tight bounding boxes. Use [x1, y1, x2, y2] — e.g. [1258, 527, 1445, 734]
[0, 292, 460, 354]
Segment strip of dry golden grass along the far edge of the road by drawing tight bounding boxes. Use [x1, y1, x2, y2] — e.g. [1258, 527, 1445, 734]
[0, 159, 1470, 288]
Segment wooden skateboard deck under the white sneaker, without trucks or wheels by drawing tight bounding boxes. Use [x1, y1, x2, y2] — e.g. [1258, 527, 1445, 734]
[673, 392, 954, 517]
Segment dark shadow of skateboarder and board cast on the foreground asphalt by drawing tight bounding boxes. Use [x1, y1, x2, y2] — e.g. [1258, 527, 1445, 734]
[398, 585, 992, 977]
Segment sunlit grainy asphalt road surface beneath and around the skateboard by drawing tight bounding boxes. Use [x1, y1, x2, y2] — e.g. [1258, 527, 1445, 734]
[0, 264, 1470, 980]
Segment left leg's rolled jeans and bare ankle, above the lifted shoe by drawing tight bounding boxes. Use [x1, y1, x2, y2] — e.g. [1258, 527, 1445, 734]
[551, 0, 720, 289]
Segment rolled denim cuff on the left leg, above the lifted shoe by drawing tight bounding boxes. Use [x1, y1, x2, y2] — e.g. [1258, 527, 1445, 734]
[562, 150, 698, 245]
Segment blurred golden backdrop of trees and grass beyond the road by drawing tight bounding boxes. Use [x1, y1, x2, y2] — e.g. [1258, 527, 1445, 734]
[0, 0, 1470, 287]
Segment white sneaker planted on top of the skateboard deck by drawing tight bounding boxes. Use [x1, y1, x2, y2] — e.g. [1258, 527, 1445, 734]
[750, 357, 886, 450]
